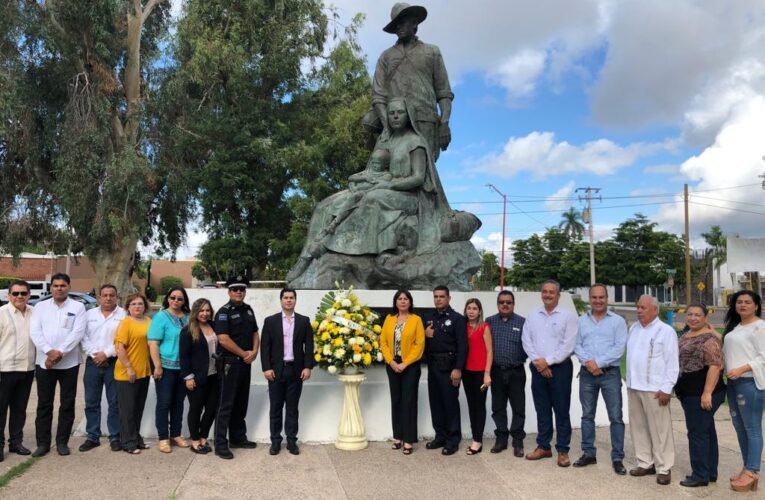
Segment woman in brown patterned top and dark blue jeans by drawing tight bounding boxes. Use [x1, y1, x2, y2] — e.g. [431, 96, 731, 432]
[675, 304, 725, 488]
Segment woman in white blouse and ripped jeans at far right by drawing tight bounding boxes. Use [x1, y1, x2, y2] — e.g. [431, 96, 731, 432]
[723, 290, 765, 491]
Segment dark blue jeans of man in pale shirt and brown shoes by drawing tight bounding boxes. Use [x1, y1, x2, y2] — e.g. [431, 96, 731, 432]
[531, 359, 574, 453]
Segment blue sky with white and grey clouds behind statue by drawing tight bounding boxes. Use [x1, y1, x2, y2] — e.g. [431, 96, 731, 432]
[175, 0, 765, 261]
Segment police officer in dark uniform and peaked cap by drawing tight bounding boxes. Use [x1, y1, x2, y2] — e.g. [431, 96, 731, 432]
[215, 276, 260, 459]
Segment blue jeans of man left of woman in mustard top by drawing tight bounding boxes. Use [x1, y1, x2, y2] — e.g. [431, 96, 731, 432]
[82, 357, 120, 443]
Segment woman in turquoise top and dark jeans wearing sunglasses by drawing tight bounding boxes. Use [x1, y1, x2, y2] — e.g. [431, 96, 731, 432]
[148, 286, 189, 453]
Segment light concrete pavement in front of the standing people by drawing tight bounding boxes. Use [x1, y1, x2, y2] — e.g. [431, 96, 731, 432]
[0, 385, 762, 500]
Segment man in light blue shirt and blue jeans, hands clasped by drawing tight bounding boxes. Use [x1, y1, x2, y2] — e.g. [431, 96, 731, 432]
[574, 283, 627, 476]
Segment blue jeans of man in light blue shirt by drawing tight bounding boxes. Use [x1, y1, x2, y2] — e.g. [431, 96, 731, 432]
[579, 366, 624, 462]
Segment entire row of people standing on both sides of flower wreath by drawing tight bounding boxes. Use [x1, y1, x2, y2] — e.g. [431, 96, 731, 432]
[0, 273, 765, 491]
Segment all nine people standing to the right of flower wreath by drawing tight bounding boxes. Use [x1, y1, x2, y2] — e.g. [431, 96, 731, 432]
[380, 280, 765, 491]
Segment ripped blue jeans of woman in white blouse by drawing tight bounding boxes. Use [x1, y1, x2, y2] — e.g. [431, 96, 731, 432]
[728, 377, 765, 472]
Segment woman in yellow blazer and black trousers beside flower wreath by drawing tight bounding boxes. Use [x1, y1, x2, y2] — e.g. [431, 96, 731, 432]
[380, 290, 425, 455]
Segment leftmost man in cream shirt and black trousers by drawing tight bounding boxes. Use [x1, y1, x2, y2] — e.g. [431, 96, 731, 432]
[0, 280, 35, 462]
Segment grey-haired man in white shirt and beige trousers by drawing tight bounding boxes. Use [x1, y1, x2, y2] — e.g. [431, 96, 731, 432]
[627, 295, 680, 485]
